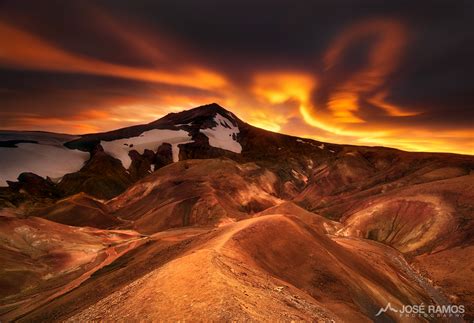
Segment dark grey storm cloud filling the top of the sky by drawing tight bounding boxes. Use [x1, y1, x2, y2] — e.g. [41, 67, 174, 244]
[2, 0, 474, 83]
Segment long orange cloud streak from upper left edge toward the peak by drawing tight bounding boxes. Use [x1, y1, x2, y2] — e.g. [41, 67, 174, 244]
[0, 21, 226, 89]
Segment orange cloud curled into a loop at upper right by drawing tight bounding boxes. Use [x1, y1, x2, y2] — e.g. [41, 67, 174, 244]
[316, 19, 417, 123]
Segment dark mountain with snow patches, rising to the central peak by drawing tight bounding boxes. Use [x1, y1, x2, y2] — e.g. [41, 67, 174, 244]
[0, 104, 337, 198]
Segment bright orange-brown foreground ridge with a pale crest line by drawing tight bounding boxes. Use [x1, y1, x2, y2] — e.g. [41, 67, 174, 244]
[13, 214, 452, 322]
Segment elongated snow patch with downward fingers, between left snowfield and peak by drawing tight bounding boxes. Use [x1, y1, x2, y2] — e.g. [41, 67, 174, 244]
[100, 129, 193, 169]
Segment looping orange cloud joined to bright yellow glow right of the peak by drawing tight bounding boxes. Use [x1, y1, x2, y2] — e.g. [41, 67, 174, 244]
[248, 19, 473, 153]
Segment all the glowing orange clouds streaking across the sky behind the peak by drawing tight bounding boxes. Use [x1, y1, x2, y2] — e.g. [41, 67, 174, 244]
[0, 7, 474, 154]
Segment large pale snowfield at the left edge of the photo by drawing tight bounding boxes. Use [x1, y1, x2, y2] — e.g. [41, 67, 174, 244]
[0, 131, 89, 186]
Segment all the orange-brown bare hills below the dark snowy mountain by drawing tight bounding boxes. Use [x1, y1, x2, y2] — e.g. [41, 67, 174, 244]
[0, 163, 474, 322]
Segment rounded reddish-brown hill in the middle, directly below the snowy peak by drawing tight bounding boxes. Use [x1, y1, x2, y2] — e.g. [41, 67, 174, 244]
[108, 159, 280, 233]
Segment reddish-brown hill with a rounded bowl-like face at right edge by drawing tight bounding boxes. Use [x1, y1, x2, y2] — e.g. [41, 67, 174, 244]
[341, 175, 474, 254]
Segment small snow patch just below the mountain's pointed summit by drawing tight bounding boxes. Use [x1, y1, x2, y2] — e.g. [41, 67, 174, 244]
[200, 113, 242, 154]
